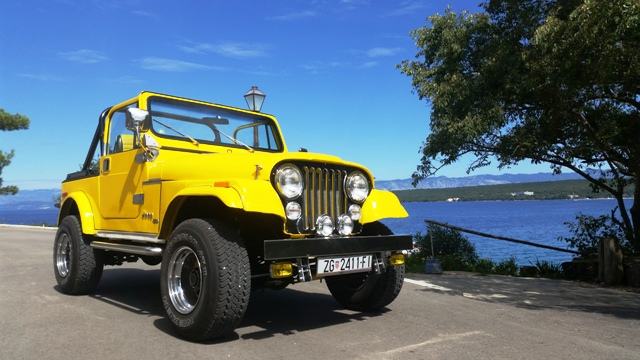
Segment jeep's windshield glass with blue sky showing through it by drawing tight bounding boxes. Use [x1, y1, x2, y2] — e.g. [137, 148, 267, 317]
[148, 97, 282, 151]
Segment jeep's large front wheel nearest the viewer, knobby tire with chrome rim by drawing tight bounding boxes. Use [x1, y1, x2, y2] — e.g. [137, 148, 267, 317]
[161, 219, 251, 341]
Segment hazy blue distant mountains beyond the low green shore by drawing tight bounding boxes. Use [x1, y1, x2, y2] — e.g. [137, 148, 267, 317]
[376, 173, 582, 190]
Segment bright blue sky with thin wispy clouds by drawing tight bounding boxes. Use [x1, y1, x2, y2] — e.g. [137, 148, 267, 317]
[0, 0, 549, 189]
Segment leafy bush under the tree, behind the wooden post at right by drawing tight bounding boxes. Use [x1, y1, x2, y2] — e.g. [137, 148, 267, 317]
[559, 214, 631, 257]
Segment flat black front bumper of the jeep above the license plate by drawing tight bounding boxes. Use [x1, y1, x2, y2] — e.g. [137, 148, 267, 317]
[264, 235, 413, 260]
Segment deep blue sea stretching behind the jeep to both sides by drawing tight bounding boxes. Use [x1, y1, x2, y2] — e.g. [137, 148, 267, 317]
[0, 199, 631, 265]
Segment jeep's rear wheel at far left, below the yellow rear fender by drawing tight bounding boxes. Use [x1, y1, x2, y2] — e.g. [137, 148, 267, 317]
[53, 215, 104, 295]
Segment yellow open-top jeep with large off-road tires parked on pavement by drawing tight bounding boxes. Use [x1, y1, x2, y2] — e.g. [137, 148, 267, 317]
[53, 92, 412, 340]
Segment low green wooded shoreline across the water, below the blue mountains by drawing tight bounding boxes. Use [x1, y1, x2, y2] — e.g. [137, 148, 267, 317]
[394, 180, 634, 201]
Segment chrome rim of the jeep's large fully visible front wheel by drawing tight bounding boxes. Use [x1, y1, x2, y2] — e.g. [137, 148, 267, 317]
[167, 246, 202, 315]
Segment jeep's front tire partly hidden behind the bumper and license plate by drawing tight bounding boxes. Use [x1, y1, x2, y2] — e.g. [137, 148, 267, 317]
[326, 222, 405, 312]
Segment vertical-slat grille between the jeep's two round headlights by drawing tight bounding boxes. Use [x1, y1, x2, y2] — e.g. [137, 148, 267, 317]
[302, 166, 347, 230]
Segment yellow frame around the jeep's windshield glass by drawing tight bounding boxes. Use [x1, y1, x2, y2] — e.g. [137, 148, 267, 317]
[146, 93, 286, 153]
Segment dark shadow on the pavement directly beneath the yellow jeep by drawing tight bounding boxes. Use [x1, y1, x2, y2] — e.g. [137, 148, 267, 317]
[82, 268, 384, 344]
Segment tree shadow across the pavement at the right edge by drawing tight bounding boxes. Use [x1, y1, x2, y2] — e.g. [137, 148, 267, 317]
[407, 273, 640, 319]
